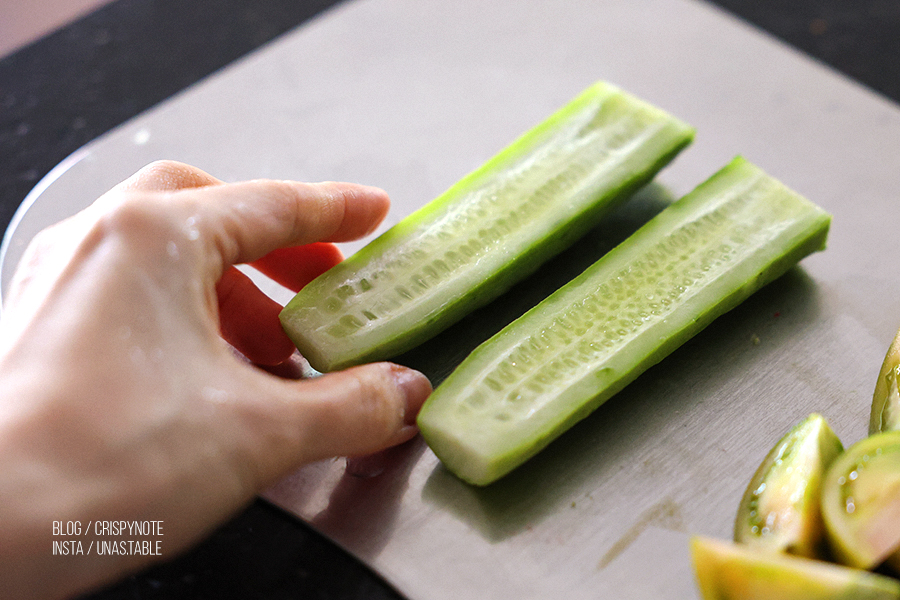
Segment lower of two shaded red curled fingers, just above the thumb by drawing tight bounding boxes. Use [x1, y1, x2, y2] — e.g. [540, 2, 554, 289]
[216, 267, 294, 366]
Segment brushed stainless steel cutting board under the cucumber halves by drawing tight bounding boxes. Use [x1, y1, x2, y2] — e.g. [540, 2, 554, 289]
[0, 0, 900, 600]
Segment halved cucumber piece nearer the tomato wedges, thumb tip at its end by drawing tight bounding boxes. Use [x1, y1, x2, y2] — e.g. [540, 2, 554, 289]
[418, 157, 831, 485]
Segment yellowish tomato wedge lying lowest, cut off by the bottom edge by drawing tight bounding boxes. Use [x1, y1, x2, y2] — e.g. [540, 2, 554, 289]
[691, 536, 900, 600]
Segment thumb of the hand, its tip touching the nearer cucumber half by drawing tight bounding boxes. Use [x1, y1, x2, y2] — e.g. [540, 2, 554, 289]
[243, 362, 431, 483]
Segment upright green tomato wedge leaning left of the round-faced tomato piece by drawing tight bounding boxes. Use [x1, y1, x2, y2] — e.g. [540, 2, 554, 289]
[734, 414, 844, 558]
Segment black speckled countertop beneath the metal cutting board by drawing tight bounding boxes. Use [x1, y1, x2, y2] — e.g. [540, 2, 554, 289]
[0, 0, 900, 599]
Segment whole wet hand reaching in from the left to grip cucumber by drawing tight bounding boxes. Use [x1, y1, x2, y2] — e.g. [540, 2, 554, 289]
[0, 162, 431, 598]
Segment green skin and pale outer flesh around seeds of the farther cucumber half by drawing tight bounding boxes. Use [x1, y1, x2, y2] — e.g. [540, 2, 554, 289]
[281, 82, 694, 371]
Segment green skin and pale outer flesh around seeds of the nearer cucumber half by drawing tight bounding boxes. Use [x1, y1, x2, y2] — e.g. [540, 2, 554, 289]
[418, 157, 831, 485]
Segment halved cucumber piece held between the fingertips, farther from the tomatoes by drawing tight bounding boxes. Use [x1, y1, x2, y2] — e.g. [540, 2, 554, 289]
[281, 82, 694, 371]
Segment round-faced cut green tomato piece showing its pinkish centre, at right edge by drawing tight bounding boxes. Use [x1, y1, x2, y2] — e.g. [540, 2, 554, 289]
[822, 431, 900, 569]
